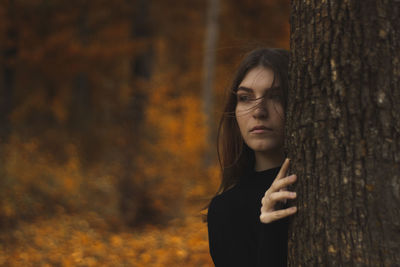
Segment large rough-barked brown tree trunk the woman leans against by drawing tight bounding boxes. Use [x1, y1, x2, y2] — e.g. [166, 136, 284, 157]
[287, 0, 400, 266]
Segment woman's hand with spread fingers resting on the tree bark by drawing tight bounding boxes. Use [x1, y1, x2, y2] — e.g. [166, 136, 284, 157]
[260, 159, 297, 223]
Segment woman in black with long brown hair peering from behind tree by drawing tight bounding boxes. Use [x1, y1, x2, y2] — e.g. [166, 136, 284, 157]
[207, 49, 296, 267]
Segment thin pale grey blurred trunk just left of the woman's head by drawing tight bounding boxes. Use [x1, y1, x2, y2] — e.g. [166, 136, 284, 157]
[203, 0, 220, 166]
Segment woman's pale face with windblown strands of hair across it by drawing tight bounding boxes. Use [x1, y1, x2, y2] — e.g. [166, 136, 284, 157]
[235, 67, 284, 153]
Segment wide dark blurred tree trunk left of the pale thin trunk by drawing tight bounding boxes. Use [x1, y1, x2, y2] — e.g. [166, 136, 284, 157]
[118, 0, 156, 226]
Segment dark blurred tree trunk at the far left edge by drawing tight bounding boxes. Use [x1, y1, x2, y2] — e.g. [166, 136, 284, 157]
[0, 0, 18, 144]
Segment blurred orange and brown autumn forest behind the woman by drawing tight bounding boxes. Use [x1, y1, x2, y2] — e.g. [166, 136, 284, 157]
[0, 0, 289, 266]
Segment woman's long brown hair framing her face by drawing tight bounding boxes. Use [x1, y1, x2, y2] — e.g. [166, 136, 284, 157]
[217, 48, 289, 194]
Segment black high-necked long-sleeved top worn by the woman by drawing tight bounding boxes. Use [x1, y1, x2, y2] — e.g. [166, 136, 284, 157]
[207, 168, 288, 267]
